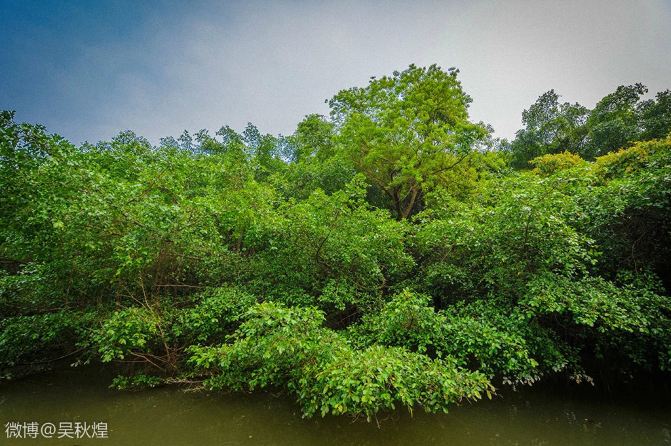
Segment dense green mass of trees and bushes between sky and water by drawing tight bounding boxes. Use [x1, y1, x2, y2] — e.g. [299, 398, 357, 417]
[0, 65, 671, 419]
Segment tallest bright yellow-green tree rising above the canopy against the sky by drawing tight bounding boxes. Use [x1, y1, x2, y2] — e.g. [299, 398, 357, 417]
[329, 65, 487, 219]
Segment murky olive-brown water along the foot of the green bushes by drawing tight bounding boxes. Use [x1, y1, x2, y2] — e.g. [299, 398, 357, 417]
[0, 369, 671, 446]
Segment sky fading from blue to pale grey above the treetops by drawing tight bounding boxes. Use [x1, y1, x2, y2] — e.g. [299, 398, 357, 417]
[0, 0, 671, 143]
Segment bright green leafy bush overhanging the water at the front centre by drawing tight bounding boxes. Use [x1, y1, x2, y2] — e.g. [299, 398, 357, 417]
[189, 303, 493, 419]
